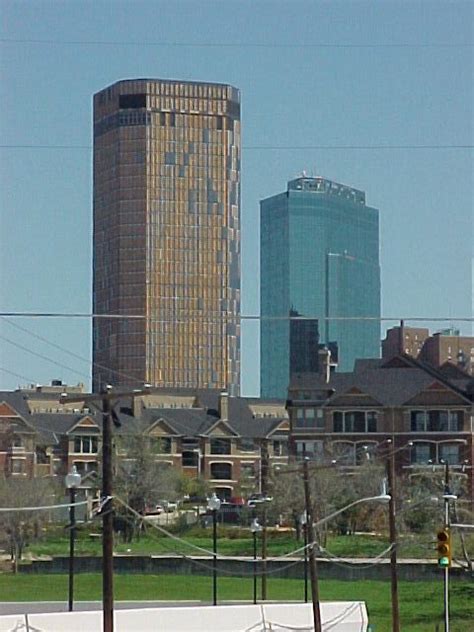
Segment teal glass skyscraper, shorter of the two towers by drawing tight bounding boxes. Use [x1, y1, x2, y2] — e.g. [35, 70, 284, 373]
[260, 176, 380, 397]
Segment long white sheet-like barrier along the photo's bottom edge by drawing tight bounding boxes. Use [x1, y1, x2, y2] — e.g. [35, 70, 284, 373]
[0, 601, 368, 632]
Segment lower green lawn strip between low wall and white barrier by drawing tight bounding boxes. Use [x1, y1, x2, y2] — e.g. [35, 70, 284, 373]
[0, 574, 474, 632]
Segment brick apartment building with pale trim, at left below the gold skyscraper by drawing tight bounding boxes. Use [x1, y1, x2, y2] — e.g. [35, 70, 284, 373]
[0, 386, 289, 498]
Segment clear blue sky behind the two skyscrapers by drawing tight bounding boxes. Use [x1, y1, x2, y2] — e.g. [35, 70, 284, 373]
[0, 0, 474, 395]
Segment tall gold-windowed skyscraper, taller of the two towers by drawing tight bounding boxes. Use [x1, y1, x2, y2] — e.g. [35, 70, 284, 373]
[93, 79, 240, 394]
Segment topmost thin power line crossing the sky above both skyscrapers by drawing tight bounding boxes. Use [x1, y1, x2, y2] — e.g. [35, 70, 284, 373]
[0, 37, 473, 49]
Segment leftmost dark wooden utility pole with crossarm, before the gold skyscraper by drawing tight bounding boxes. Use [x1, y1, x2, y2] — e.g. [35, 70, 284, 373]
[60, 385, 150, 632]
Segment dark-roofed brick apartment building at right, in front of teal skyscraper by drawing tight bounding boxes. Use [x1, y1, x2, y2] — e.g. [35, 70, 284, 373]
[287, 354, 474, 502]
